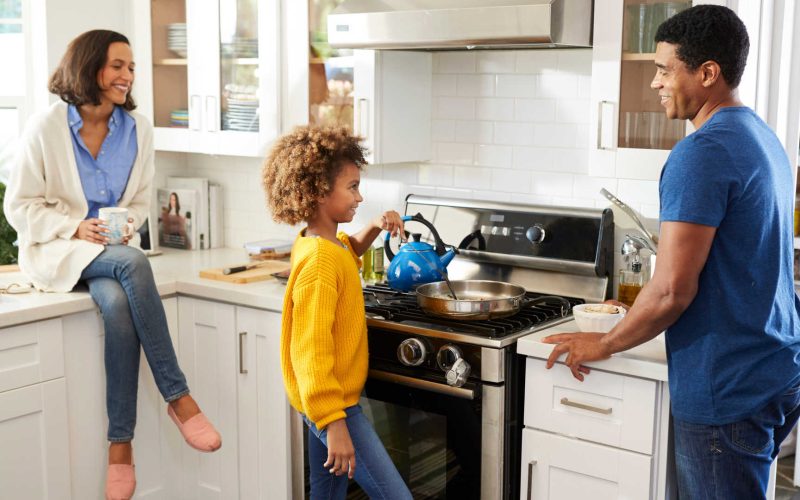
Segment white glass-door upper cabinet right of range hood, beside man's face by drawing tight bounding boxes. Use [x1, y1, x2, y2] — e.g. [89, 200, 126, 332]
[590, 0, 698, 180]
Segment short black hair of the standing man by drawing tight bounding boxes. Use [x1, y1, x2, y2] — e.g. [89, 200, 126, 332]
[655, 5, 750, 89]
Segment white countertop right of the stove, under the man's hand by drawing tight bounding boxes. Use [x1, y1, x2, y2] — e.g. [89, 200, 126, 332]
[517, 321, 667, 381]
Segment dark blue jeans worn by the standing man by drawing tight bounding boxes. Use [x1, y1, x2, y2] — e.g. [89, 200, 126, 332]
[673, 385, 800, 500]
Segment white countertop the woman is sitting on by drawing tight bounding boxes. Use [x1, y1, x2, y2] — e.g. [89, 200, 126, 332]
[0, 248, 285, 328]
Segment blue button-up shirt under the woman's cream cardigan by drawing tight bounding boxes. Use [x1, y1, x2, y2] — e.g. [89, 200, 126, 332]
[67, 104, 139, 219]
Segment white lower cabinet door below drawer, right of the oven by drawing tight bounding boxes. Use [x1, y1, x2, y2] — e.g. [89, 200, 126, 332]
[520, 428, 652, 500]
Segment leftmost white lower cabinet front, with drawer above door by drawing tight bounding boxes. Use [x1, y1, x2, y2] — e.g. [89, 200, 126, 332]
[0, 319, 70, 500]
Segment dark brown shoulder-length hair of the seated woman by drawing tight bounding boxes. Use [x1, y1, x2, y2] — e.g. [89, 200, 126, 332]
[47, 30, 136, 111]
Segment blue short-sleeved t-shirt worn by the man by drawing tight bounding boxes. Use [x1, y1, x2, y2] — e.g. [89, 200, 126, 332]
[659, 107, 800, 425]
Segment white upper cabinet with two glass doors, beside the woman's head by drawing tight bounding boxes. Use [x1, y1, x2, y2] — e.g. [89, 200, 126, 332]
[136, 0, 280, 156]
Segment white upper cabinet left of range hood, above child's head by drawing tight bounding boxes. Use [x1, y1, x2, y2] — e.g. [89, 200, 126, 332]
[282, 0, 433, 163]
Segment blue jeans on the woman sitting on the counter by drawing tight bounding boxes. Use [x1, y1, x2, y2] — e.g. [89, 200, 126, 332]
[81, 245, 189, 442]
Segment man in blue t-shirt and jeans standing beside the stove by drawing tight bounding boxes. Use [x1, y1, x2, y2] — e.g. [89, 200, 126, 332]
[544, 5, 800, 499]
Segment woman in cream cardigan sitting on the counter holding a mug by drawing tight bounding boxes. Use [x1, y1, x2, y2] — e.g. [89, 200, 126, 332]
[3, 30, 221, 499]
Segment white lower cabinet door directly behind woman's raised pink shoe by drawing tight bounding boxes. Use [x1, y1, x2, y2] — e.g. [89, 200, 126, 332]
[178, 297, 239, 500]
